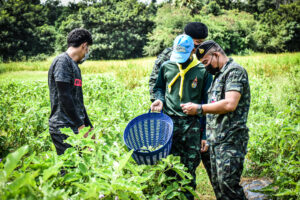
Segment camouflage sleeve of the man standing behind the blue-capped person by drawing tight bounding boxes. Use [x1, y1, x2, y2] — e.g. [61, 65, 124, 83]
[149, 47, 173, 102]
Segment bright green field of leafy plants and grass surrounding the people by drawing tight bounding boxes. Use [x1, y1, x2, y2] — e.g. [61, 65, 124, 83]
[0, 53, 300, 199]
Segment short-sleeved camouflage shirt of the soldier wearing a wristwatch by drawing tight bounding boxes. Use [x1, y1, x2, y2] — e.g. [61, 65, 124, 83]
[206, 58, 251, 144]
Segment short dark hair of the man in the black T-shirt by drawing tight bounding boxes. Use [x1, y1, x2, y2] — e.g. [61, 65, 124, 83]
[67, 28, 93, 47]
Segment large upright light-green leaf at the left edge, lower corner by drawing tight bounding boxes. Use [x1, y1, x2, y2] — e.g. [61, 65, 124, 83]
[0, 145, 28, 182]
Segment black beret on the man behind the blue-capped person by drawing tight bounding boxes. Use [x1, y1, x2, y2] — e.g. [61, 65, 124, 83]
[184, 22, 208, 39]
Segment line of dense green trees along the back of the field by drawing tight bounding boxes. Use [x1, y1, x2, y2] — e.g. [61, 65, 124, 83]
[0, 0, 300, 62]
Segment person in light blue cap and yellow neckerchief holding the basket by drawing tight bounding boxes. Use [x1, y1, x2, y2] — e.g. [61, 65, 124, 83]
[151, 35, 212, 199]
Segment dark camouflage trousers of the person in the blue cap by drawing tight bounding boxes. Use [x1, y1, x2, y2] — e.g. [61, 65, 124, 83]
[171, 116, 210, 200]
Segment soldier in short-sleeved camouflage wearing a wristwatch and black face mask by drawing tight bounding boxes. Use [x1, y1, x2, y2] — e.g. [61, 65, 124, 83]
[183, 41, 250, 200]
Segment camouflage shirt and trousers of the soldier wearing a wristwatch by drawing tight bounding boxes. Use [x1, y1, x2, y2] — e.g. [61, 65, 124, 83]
[206, 58, 250, 200]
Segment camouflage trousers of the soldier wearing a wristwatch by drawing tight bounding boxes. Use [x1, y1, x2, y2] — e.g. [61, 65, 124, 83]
[210, 140, 248, 200]
